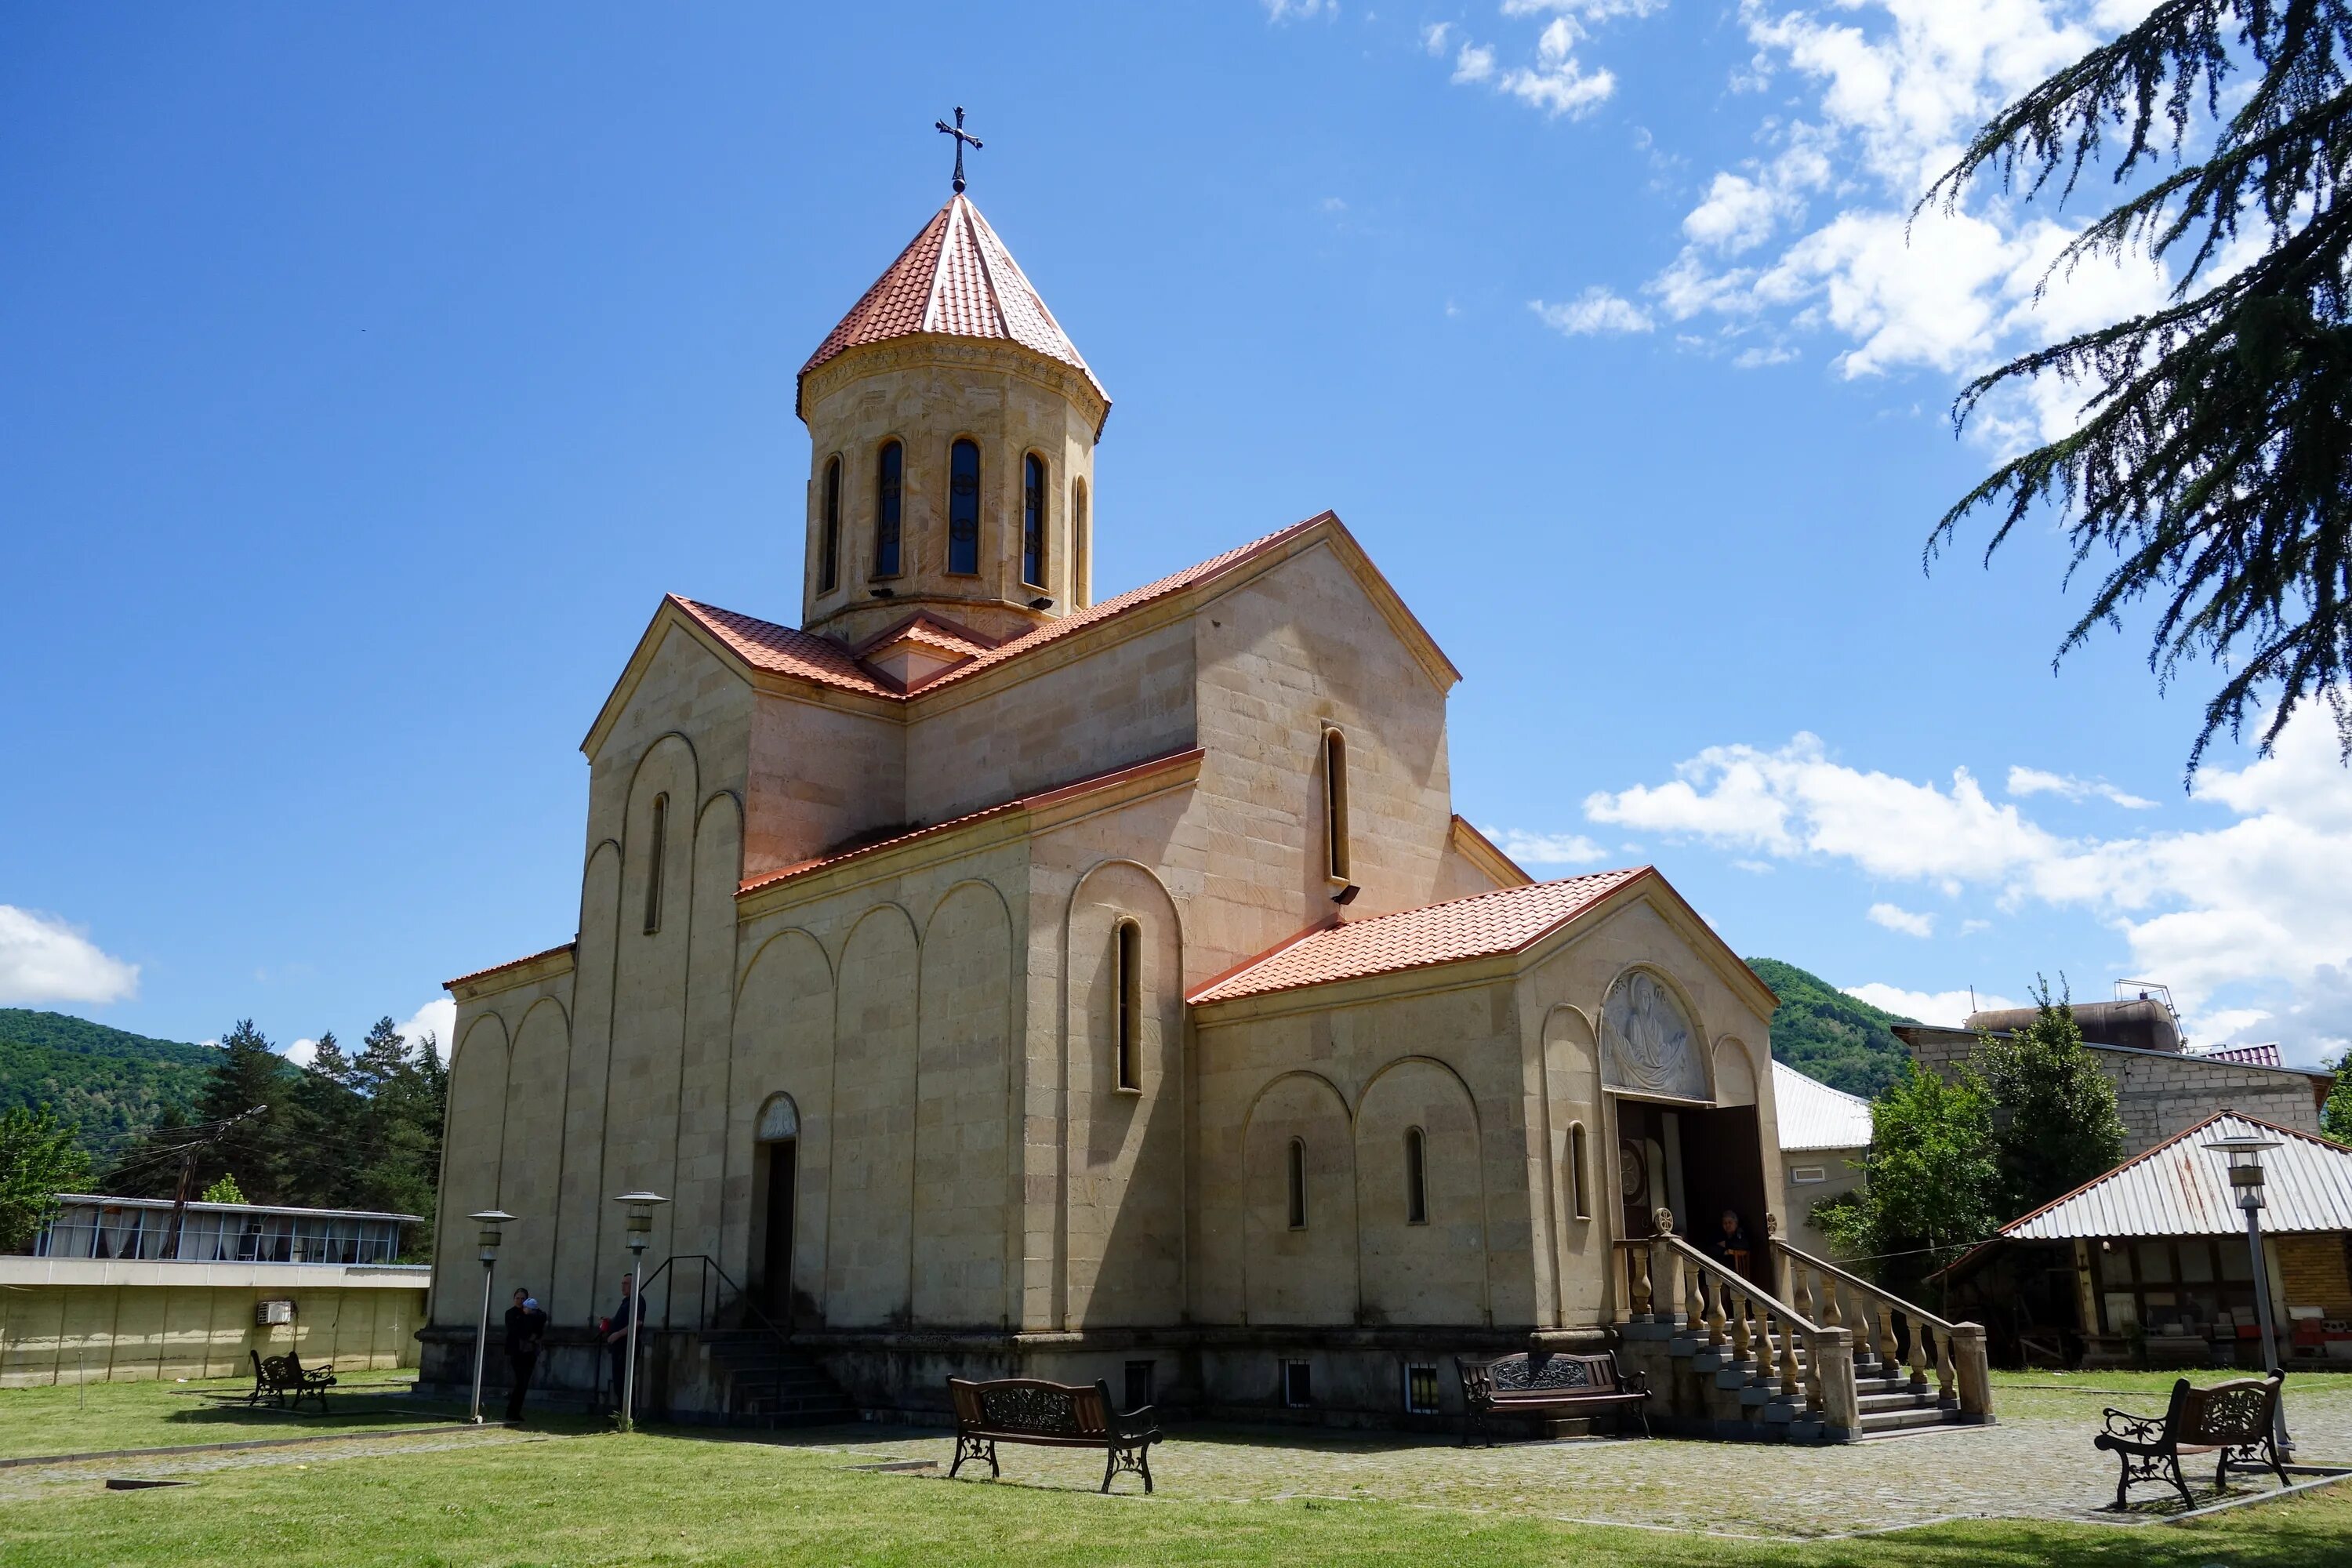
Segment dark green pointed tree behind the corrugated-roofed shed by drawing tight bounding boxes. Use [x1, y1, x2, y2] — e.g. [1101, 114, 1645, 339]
[1969, 980, 2124, 1220]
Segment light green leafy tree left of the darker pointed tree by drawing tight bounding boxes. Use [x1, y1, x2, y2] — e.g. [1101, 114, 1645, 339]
[1813, 1062, 1999, 1281]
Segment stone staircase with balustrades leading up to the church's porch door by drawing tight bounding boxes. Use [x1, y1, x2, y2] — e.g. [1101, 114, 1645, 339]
[1616, 1215, 1992, 1443]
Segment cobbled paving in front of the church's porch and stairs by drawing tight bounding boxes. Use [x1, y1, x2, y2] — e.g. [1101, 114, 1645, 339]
[809, 1377, 2352, 1540]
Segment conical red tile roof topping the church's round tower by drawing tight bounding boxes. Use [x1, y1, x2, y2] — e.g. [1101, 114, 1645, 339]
[800, 195, 1110, 416]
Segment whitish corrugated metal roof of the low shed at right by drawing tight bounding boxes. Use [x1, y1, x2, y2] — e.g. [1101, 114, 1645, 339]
[2002, 1109, 2352, 1241]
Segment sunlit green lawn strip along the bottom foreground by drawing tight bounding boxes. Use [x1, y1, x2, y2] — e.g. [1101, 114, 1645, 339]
[0, 1432, 2352, 1568]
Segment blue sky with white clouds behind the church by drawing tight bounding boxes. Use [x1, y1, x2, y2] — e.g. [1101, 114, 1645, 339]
[0, 0, 2352, 1060]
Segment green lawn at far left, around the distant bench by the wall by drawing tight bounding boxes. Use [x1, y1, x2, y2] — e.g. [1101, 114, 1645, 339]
[0, 1370, 501, 1460]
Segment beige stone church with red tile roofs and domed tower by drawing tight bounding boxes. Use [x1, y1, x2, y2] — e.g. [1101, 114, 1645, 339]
[423, 191, 1780, 1422]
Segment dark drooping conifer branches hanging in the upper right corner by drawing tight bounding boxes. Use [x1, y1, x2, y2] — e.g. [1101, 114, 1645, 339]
[1922, 0, 2352, 771]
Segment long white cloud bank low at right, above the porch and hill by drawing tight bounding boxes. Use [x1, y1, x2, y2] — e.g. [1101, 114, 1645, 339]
[1585, 706, 2352, 1053]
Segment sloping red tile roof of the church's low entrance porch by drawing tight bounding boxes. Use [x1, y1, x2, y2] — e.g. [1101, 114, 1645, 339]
[1190, 865, 1656, 1004]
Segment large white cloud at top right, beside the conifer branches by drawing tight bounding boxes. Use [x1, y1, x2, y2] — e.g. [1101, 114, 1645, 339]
[1618, 0, 2183, 404]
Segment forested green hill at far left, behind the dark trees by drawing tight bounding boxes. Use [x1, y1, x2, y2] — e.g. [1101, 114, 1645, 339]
[0, 1006, 221, 1163]
